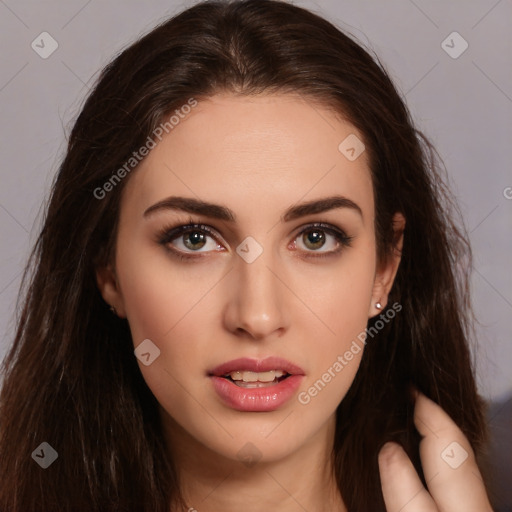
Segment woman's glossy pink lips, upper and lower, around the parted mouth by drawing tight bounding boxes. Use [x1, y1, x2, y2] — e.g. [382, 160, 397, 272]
[209, 357, 304, 412]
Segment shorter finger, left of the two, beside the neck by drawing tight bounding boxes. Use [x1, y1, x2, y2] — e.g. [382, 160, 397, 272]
[379, 443, 438, 512]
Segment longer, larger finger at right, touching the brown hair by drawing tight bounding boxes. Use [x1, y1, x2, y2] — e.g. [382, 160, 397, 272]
[414, 393, 492, 512]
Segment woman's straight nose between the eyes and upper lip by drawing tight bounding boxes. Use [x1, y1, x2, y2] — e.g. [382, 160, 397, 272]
[224, 251, 290, 340]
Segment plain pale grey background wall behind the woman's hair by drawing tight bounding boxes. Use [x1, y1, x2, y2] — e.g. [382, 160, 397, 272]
[0, 0, 512, 404]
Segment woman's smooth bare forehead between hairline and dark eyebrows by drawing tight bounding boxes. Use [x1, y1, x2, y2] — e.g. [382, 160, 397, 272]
[125, 94, 373, 222]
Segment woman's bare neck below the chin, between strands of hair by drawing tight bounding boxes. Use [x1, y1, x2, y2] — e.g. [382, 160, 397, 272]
[161, 411, 347, 512]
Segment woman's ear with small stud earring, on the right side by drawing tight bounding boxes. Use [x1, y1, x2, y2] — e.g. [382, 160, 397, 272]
[368, 212, 405, 318]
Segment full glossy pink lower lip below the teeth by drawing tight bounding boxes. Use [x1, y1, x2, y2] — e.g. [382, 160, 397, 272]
[211, 375, 304, 412]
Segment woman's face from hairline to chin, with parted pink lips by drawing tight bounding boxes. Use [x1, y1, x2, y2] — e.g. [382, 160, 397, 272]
[98, 95, 396, 461]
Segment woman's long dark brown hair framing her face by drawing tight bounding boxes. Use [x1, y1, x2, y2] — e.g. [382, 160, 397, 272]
[0, 0, 486, 512]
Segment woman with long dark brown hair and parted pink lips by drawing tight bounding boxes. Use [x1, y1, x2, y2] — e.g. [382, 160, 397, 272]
[0, 0, 491, 512]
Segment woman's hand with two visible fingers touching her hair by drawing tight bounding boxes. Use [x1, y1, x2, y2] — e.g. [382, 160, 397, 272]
[379, 392, 492, 512]
